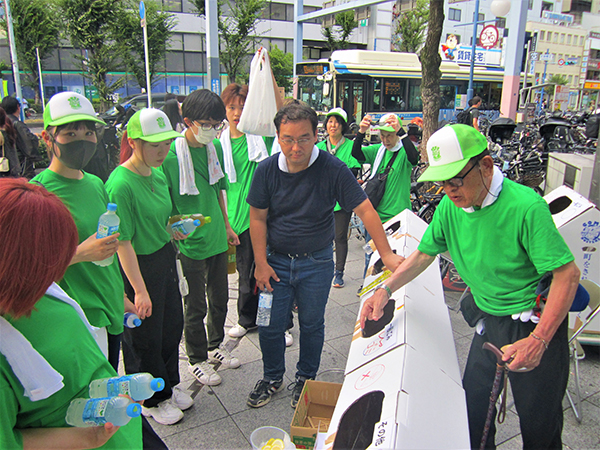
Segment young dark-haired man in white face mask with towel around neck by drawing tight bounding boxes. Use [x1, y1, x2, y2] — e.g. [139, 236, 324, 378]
[160, 89, 240, 386]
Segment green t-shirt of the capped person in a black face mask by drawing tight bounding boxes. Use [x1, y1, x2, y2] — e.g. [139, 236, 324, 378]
[32, 169, 125, 334]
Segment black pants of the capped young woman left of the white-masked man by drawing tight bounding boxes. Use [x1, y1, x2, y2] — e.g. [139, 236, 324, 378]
[123, 242, 183, 407]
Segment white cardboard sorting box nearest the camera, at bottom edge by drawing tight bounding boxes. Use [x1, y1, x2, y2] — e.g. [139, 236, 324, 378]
[319, 345, 470, 450]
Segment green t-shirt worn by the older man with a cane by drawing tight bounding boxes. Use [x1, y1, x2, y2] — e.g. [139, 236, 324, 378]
[419, 179, 573, 316]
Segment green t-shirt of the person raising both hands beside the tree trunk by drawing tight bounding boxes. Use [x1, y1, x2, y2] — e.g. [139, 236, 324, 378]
[362, 144, 413, 222]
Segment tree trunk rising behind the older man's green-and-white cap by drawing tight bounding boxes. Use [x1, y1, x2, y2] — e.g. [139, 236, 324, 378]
[419, 0, 444, 161]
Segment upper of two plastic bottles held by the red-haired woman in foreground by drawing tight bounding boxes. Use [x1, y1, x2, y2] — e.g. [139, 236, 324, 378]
[90, 373, 165, 402]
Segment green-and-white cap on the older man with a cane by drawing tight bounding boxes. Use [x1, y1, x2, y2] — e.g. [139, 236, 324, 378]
[418, 124, 488, 181]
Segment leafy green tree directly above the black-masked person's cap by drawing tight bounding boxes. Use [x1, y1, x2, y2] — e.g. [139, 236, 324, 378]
[62, 0, 125, 111]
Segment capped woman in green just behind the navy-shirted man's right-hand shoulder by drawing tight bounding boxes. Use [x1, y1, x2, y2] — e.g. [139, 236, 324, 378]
[317, 108, 361, 288]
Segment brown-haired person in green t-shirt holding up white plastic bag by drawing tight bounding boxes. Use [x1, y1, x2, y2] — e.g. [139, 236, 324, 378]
[219, 82, 293, 345]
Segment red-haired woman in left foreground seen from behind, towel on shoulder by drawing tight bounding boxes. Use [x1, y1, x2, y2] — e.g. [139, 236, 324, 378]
[0, 178, 142, 449]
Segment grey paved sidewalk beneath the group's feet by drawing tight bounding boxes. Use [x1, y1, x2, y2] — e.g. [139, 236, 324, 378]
[150, 236, 600, 450]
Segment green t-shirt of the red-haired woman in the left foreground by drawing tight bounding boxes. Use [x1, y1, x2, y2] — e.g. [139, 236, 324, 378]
[0, 294, 142, 449]
